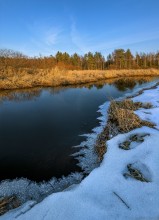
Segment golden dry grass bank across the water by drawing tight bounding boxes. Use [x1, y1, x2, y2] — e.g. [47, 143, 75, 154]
[0, 67, 159, 90]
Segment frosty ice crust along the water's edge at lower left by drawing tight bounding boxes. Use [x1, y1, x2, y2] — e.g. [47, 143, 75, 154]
[0, 172, 83, 204]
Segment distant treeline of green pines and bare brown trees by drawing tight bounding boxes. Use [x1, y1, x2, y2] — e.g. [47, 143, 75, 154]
[0, 49, 159, 70]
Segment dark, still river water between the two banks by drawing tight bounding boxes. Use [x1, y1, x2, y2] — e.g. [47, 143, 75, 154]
[0, 78, 157, 181]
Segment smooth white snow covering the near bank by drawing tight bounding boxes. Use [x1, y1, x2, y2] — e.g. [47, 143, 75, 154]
[0, 83, 159, 220]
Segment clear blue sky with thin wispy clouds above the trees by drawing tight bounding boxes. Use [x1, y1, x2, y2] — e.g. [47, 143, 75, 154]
[0, 0, 159, 56]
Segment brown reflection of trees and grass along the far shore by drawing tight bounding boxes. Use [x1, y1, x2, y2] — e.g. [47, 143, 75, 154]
[0, 77, 156, 102]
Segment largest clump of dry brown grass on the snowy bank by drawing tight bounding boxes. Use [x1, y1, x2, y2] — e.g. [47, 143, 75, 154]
[95, 99, 155, 161]
